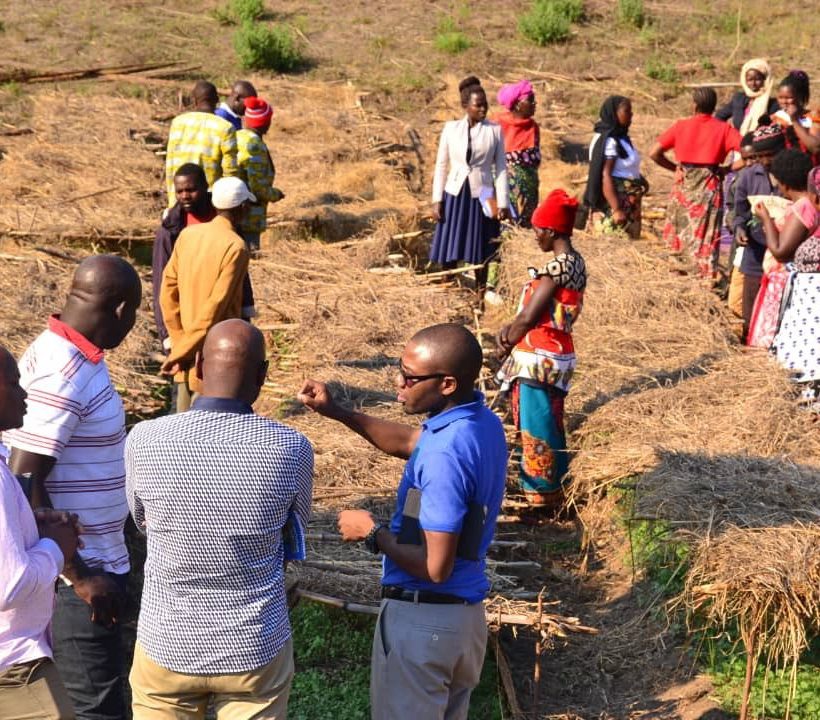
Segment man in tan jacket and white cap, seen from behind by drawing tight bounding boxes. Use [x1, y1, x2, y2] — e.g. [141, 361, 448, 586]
[159, 177, 251, 412]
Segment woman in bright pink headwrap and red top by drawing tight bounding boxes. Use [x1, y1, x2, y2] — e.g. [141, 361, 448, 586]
[492, 80, 541, 227]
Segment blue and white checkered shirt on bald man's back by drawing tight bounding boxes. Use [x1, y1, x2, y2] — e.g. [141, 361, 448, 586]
[125, 398, 313, 675]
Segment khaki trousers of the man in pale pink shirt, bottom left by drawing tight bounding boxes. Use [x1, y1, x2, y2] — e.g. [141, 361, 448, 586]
[0, 658, 74, 720]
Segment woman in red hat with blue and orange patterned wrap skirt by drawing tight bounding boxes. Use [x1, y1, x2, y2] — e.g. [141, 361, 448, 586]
[498, 190, 587, 507]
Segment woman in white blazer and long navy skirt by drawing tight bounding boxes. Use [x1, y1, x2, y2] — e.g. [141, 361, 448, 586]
[430, 76, 510, 294]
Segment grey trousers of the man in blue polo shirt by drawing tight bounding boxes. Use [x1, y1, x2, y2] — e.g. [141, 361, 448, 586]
[370, 600, 487, 720]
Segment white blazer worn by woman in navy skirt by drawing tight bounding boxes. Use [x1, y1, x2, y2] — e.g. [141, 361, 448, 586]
[433, 115, 510, 208]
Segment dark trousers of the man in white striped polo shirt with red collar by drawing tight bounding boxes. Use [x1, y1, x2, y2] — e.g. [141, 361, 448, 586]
[51, 574, 128, 720]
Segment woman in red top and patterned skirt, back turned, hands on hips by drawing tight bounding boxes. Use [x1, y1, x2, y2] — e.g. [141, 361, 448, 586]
[649, 88, 740, 278]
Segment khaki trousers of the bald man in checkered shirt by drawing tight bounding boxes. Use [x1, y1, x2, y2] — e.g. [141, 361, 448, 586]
[130, 640, 293, 720]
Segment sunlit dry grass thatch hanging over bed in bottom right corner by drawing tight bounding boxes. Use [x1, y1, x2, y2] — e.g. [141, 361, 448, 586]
[682, 524, 820, 720]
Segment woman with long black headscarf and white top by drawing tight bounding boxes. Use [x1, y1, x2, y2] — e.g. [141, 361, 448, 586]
[584, 95, 649, 239]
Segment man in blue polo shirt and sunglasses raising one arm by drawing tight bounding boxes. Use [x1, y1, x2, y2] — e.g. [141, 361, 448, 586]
[299, 324, 507, 720]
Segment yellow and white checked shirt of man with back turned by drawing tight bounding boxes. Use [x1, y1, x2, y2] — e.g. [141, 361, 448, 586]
[165, 110, 237, 207]
